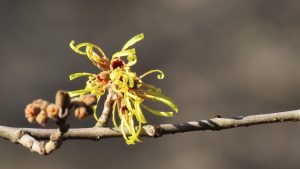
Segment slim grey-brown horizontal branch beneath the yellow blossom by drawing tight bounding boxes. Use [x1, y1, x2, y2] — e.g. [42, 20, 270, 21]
[0, 110, 300, 155]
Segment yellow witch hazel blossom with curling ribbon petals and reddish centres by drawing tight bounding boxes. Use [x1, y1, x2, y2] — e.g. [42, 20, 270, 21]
[69, 34, 178, 144]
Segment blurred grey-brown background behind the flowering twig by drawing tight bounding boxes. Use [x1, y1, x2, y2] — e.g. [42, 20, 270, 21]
[0, 0, 300, 169]
